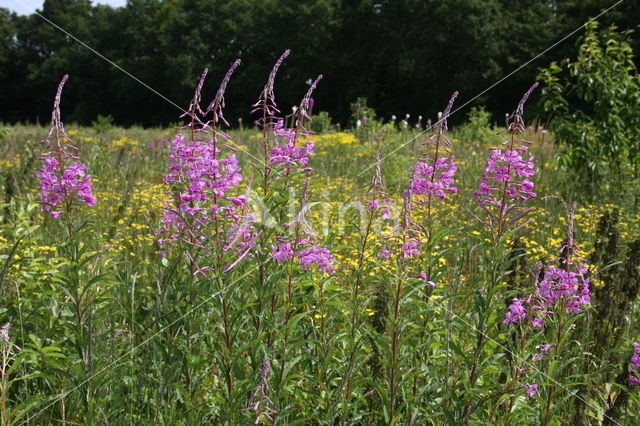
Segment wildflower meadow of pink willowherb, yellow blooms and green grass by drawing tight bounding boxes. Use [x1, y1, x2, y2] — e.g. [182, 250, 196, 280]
[0, 31, 640, 425]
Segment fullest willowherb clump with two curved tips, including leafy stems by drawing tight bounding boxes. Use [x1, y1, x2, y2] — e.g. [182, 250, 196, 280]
[159, 60, 276, 423]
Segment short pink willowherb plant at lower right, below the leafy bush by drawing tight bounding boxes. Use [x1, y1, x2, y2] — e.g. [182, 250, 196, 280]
[503, 203, 593, 424]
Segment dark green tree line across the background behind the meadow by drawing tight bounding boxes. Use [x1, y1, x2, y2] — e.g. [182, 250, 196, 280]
[0, 0, 640, 126]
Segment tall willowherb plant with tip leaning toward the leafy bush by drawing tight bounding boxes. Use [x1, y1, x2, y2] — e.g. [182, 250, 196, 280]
[458, 83, 538, 424]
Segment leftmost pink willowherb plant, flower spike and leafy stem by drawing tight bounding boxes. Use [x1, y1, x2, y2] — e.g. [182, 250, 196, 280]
[30, 75, 112, 417]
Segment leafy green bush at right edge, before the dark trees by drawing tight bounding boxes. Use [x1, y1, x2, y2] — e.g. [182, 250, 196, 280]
[540, 23, 640, 189]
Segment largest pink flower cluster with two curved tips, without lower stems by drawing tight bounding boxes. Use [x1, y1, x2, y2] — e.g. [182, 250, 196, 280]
[158, 61, 258, 271]
